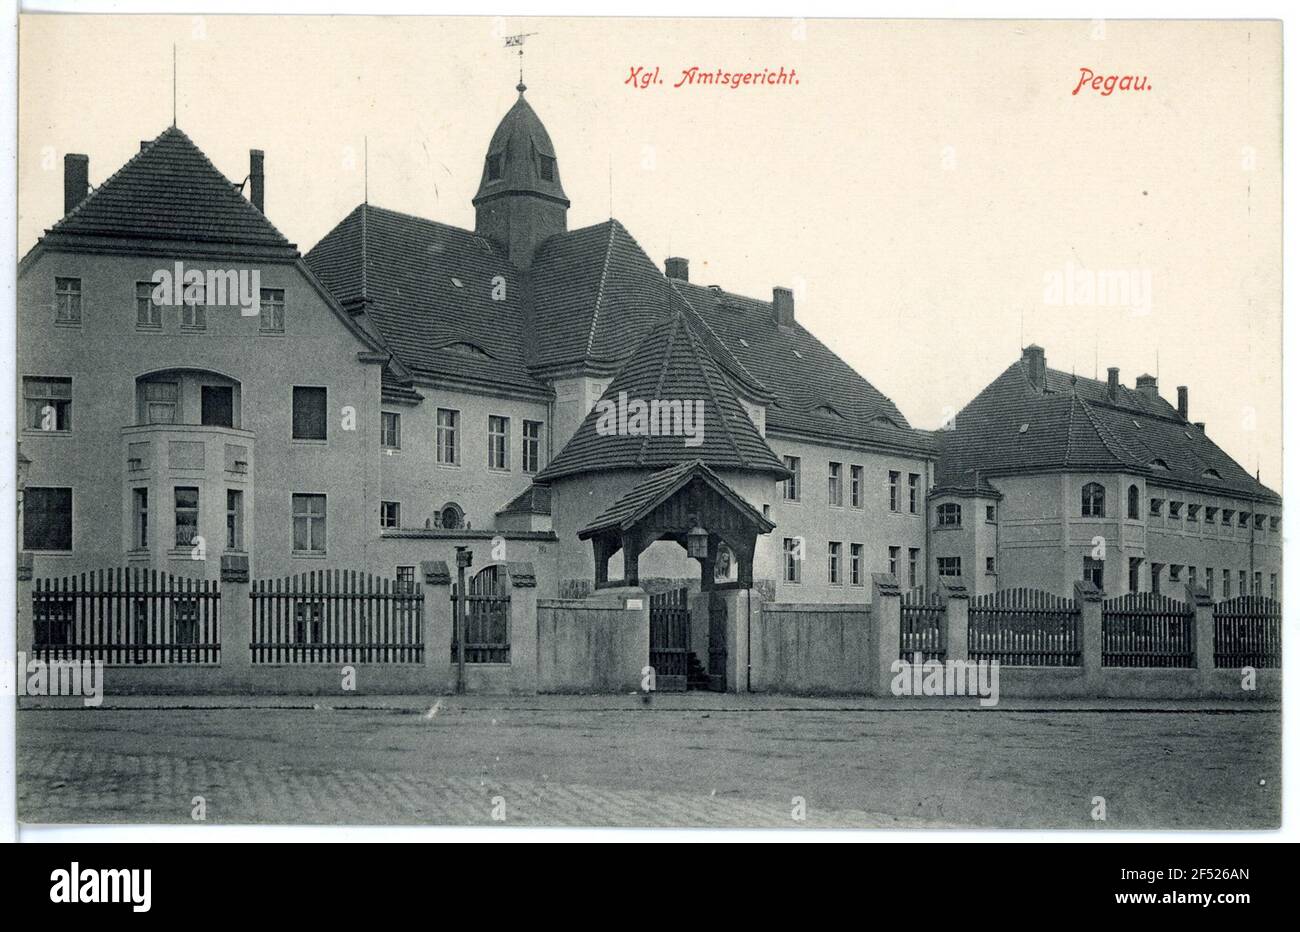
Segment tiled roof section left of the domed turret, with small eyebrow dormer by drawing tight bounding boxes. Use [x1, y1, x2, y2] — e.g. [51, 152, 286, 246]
[307, 204, 547, 393]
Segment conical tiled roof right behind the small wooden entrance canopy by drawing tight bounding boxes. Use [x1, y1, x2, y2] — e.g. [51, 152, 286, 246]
[536, 307, 789, 482]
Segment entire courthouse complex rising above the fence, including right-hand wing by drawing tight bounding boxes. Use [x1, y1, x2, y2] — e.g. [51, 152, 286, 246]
[18, 84, 1281, 603]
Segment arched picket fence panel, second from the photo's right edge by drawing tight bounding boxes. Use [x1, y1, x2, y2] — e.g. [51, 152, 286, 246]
[1101, 593, 1196, 669]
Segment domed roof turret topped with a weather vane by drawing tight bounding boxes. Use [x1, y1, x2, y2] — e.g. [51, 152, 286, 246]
[473, 82, 569, 269]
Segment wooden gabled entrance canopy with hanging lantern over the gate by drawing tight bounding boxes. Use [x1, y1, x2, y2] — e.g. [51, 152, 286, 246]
[577, 460, 776, 589]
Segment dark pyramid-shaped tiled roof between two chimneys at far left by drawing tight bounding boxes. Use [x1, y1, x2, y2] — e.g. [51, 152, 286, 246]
[42, 126, 296, 256]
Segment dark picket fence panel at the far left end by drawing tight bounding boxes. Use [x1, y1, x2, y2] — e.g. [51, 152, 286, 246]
[31, 567, 221, 664]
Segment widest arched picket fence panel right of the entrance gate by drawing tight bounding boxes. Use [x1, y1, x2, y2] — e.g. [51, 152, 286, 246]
[967, 588, 1080, 667]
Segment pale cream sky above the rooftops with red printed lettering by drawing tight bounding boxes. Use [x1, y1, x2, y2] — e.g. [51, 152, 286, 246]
[18, 14, 1282, 491]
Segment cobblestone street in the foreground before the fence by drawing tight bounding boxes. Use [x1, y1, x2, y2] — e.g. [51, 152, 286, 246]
[18, 693, 1281, 831]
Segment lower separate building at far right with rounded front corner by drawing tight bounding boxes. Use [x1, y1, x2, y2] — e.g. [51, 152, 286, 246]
[930, 346, 1282, 599]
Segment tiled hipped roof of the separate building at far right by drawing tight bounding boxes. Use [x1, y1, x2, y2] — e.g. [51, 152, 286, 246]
[936, 360, 1281, 502]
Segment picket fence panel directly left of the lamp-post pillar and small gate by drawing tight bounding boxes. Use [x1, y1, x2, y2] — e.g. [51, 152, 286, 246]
[248, 569, 424, 664]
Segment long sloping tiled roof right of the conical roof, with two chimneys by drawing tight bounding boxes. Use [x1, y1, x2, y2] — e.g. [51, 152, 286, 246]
[673, 281, 933, 454]
